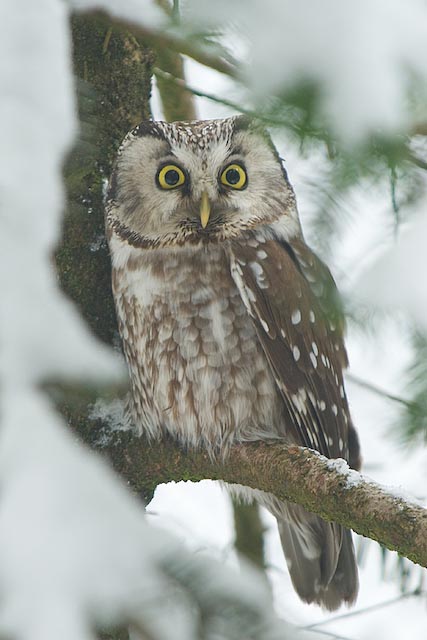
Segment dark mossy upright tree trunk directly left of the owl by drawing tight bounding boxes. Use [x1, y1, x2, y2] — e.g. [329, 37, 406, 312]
[56, 14, 153, 344]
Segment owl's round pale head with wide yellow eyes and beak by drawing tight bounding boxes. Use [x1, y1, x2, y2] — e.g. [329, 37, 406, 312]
[106, 116, 300, 248]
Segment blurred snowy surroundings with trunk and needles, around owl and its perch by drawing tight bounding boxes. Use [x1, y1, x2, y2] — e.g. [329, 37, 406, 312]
[0, 0, 427, 640]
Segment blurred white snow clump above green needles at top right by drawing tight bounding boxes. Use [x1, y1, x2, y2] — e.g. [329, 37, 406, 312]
[184, 0, 427, 143]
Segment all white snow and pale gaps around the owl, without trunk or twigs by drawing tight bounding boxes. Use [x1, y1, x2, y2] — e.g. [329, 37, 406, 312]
[0, 0, 427, 640]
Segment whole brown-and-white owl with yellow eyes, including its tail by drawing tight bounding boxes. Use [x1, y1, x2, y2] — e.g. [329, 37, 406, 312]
[106, 116, 360, 610]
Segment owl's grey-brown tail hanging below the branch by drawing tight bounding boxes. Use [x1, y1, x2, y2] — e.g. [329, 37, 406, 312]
[274, 503, 359, 611]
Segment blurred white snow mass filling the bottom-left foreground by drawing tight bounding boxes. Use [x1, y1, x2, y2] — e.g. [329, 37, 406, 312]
[0, 391, 298, 640]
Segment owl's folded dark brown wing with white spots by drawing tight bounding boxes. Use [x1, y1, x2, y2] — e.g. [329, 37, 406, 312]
[231, 232, 358, 466]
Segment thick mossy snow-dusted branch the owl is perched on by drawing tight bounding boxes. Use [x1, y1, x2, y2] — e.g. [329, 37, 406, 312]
[79, 422, 427, 567]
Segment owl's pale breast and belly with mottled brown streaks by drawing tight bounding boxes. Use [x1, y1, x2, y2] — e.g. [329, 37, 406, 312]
[113, 246, 283, 451]
